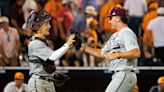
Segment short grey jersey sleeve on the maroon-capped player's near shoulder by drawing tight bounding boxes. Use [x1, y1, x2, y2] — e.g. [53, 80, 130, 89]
[121, 31, 139, 51]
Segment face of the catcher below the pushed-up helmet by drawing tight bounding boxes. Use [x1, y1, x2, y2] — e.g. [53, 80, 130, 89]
[39, 22, 51, 36]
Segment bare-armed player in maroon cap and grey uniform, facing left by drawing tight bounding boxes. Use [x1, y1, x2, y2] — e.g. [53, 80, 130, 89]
[80, 7, 140, 92]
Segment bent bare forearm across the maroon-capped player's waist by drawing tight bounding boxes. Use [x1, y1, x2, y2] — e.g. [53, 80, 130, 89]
[117, 48, 141, 59]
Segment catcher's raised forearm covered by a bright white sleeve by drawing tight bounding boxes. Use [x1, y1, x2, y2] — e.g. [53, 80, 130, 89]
[49, 44, 69, 61]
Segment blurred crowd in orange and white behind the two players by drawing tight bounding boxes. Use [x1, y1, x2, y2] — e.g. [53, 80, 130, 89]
[0, 0, 164, 67]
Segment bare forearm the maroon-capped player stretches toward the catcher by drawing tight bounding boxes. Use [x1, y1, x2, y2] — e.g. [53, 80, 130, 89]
[85, 46, 105, 59]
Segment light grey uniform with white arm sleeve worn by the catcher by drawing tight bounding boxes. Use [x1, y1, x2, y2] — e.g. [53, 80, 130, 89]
[28, 37, 69, 92]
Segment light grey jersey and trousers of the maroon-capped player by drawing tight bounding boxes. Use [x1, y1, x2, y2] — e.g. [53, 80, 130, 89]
[102, 27, 139, 92]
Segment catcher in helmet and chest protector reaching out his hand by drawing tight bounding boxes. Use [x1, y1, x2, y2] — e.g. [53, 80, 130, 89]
[27, 10, 75, 92]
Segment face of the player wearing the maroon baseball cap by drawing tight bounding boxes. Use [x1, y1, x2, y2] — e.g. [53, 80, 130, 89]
[109, 16, 120, 29]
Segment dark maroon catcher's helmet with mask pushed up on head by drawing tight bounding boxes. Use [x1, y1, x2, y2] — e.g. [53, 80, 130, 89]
[26, 10, 52, 32]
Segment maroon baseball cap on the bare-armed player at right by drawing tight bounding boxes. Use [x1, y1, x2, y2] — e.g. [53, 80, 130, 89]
[108, 7, 127, 17]
